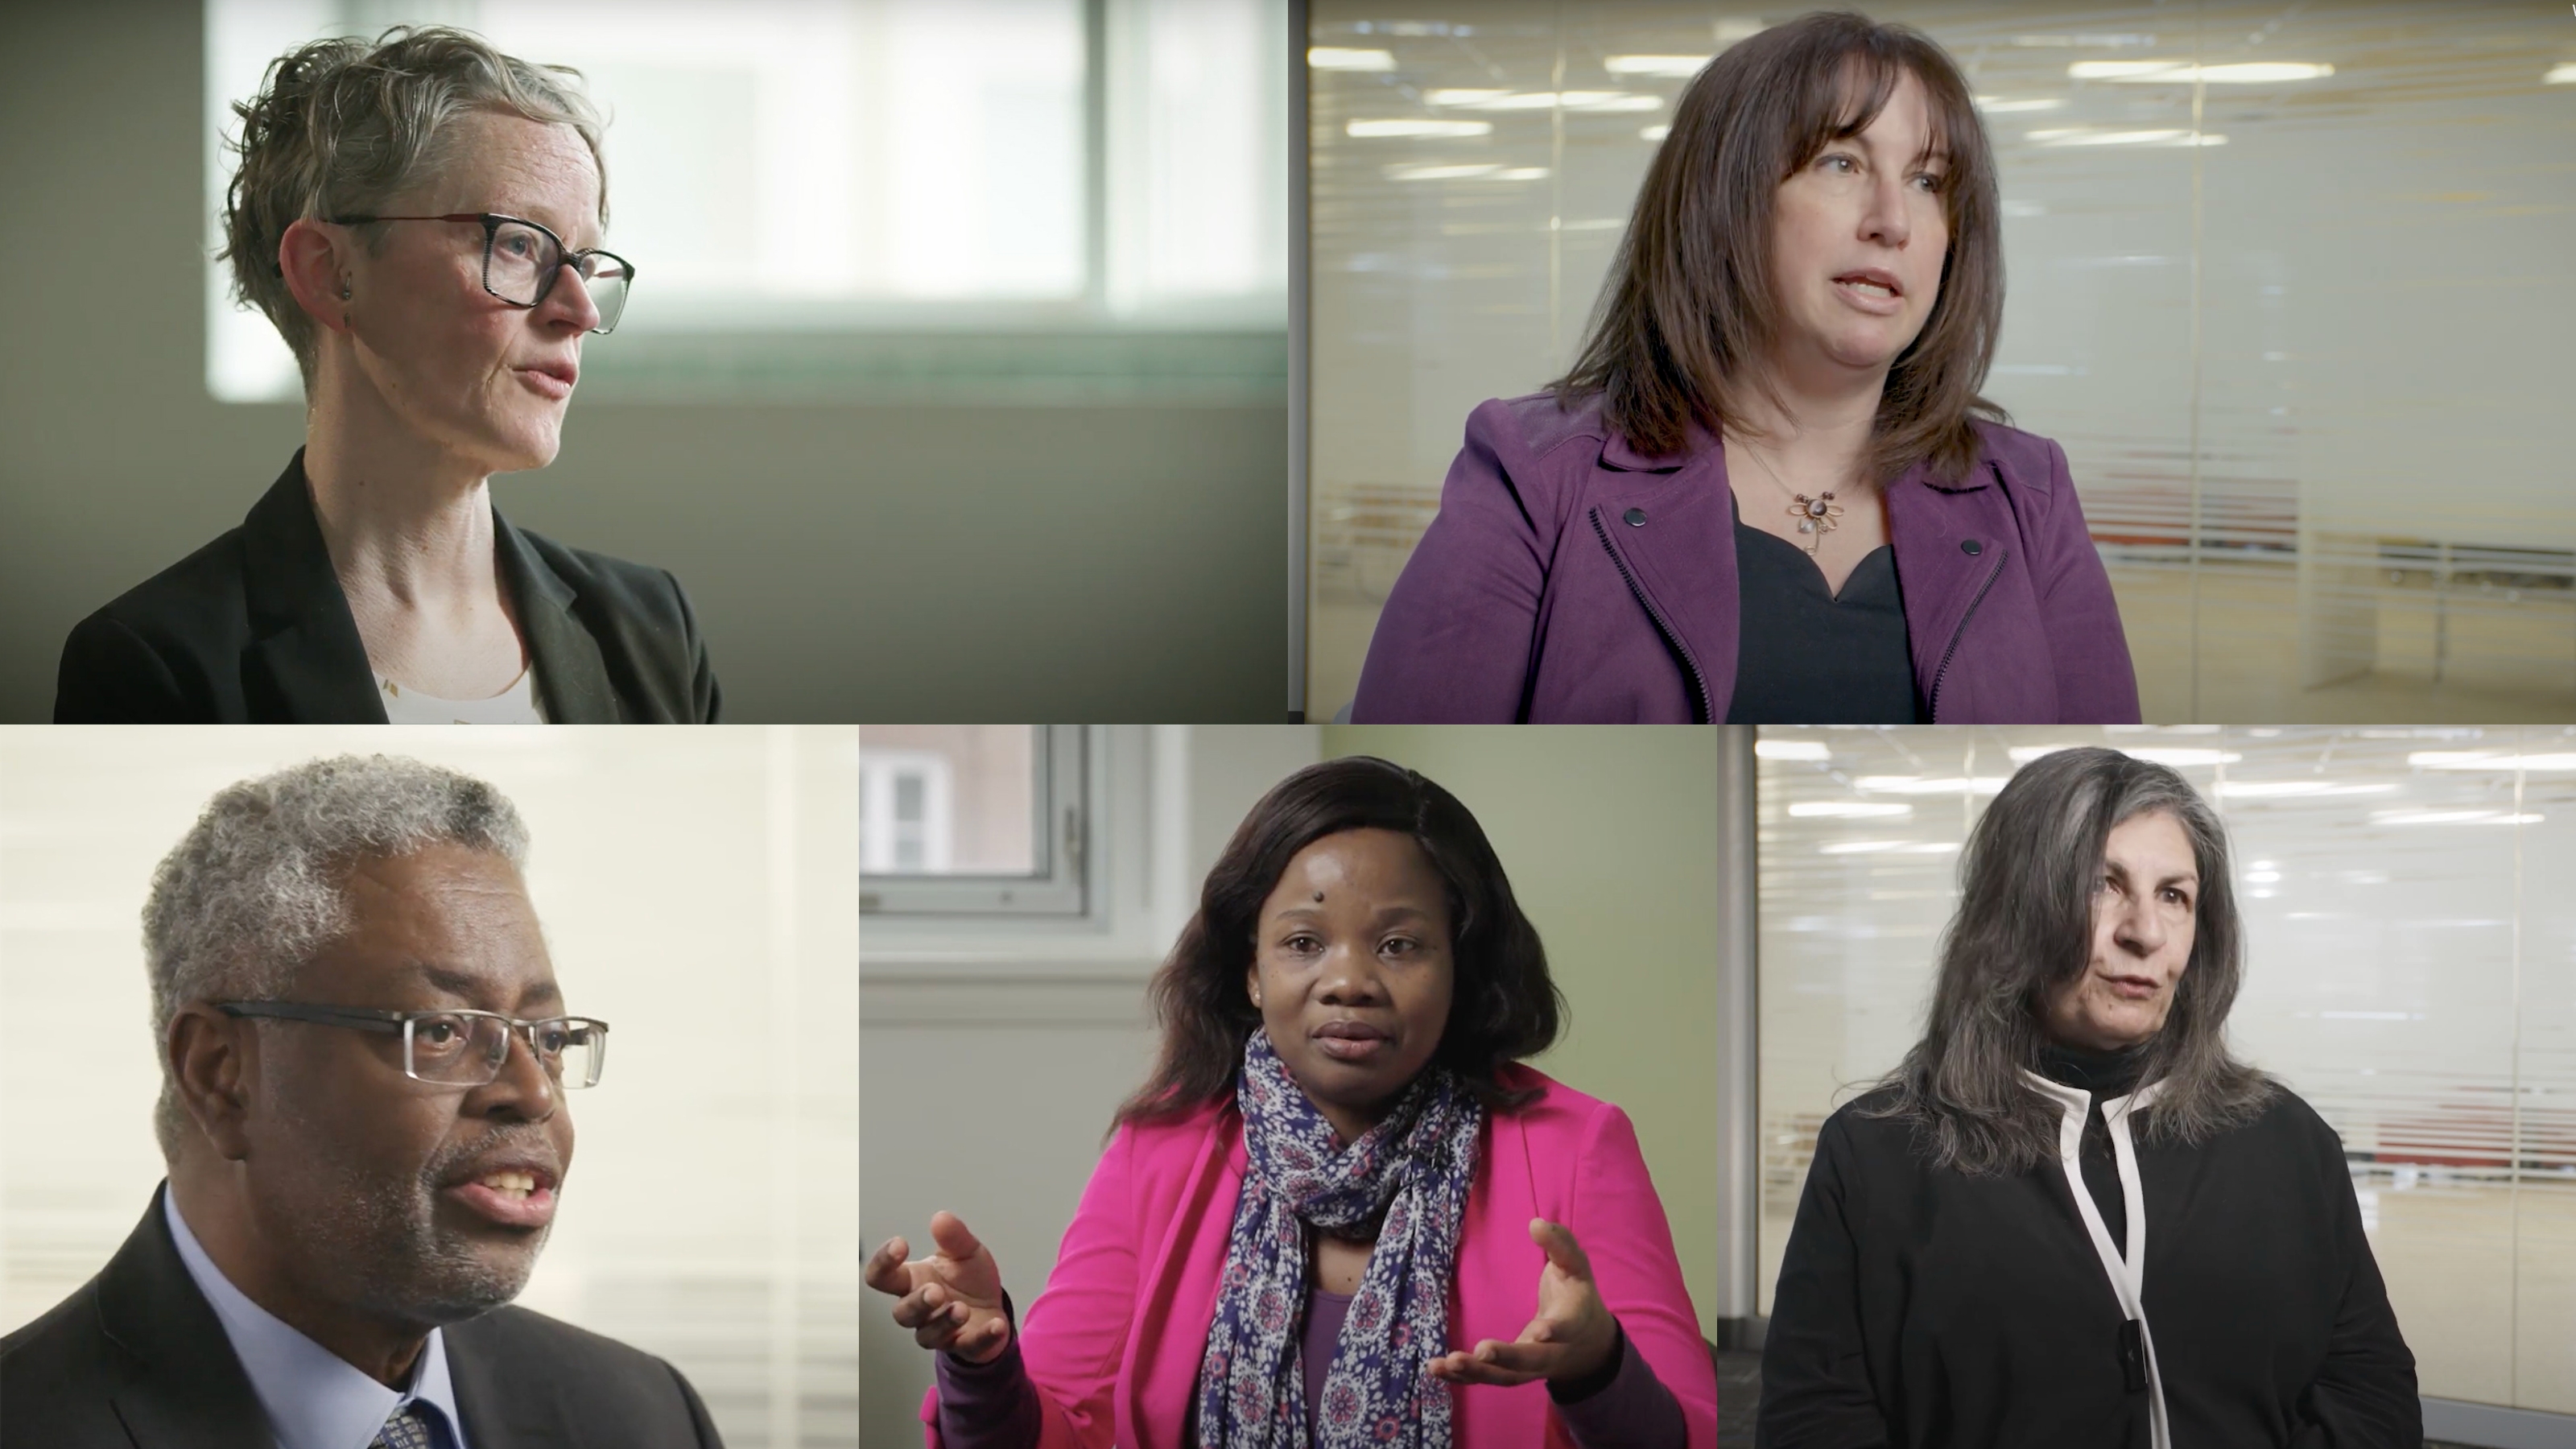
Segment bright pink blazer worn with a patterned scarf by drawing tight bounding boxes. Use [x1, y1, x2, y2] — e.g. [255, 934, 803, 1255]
[923, 1067, 1718, 1449]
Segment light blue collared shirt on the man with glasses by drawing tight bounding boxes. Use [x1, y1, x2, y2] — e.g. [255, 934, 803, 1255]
[163, 1189, 469, 1449]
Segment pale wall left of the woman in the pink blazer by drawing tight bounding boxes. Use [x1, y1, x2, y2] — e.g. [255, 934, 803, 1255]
[858, 724, 1319, 1447]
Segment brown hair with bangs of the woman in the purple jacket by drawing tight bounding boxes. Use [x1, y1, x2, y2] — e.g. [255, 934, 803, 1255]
[1550, 10, 2007, 482]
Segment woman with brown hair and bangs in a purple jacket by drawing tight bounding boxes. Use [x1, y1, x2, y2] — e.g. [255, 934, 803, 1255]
[1352, 13, 2138, 724]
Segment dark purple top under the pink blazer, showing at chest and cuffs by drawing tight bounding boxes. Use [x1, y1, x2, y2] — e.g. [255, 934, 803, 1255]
[938, 1289, 1690, 1449]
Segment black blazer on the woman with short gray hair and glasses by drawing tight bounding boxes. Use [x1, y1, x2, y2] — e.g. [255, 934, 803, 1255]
[54, 448, 721, 724]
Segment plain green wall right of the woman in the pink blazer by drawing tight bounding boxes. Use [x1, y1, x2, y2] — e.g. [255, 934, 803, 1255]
[1324, 724, 1718, 1333]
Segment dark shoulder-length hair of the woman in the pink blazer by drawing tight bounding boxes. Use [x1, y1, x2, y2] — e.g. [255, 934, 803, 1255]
[1118, 755, 1567, 1121]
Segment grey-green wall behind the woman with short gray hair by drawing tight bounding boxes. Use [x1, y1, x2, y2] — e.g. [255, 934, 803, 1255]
[0, 0, 1288, 722]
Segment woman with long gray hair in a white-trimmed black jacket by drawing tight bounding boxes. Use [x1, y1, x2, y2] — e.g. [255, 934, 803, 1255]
[1760, 750, 2424, 1449]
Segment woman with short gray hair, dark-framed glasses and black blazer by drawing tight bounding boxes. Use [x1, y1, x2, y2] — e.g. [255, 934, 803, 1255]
[54, 26, 719, 724]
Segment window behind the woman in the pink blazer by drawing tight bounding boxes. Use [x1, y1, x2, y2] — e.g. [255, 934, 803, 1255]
[858, 724, 1090, 915]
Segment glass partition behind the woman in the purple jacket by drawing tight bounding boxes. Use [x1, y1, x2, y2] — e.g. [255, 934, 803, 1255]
[1306, 0, 2576, 722]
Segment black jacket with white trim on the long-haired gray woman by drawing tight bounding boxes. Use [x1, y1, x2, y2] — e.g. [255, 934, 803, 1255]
[1754, 1072, 2424, 1449]
